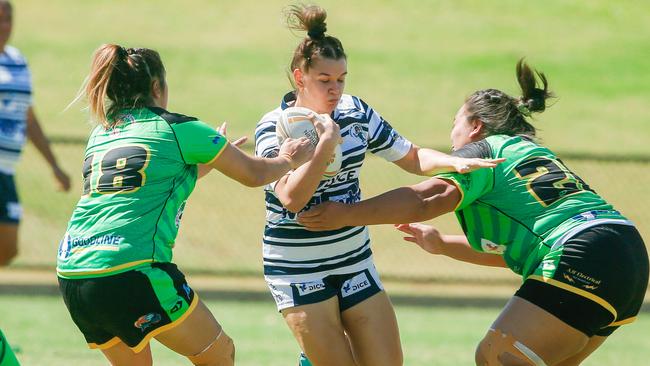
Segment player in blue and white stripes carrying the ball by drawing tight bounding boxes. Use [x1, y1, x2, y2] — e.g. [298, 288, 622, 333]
[255, 5, 502, 366]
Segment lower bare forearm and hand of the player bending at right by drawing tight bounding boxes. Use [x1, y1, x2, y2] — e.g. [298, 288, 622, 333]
[395, 223, 506, 267]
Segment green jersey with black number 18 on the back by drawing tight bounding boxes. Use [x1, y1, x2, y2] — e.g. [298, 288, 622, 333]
[57, 107, 227, 278]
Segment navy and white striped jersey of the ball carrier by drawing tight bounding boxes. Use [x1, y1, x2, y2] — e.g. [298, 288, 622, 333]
[255, 93, 411, 277]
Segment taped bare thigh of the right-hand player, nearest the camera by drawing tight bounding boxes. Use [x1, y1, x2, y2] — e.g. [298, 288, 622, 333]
[476, 296, 589, 366]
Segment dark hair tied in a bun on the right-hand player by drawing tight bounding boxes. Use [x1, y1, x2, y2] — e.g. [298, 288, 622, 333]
[465, 59, 553, 139]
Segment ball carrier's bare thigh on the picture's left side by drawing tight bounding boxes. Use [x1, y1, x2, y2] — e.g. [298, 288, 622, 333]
[282, 296, 356, 366]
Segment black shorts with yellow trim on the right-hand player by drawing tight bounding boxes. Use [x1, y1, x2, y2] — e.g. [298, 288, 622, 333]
[515, 224, 649, 337]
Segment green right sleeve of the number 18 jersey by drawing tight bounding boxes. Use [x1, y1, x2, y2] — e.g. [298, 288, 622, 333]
[171, 120, 228, 164]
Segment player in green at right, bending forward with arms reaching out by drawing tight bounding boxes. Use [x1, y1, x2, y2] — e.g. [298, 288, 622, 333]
[300, 61, 648, 366]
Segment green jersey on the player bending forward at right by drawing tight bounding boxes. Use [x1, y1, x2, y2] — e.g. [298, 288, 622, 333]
[437, 135, 629, 279]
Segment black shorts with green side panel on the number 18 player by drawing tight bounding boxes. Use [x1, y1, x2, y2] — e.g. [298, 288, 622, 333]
[59, 263, 198, 353]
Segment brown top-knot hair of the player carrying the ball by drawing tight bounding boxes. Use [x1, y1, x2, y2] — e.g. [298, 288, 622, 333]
[287, 5, 347, 76]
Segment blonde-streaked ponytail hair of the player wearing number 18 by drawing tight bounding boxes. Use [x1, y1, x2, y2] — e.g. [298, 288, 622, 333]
[75, 44, 165, 128]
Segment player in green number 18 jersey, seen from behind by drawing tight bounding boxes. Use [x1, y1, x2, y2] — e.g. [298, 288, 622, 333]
[57, 44, 313, 366]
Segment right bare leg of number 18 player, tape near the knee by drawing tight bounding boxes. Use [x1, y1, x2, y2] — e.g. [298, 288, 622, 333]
[156, 301, 235, 366]
